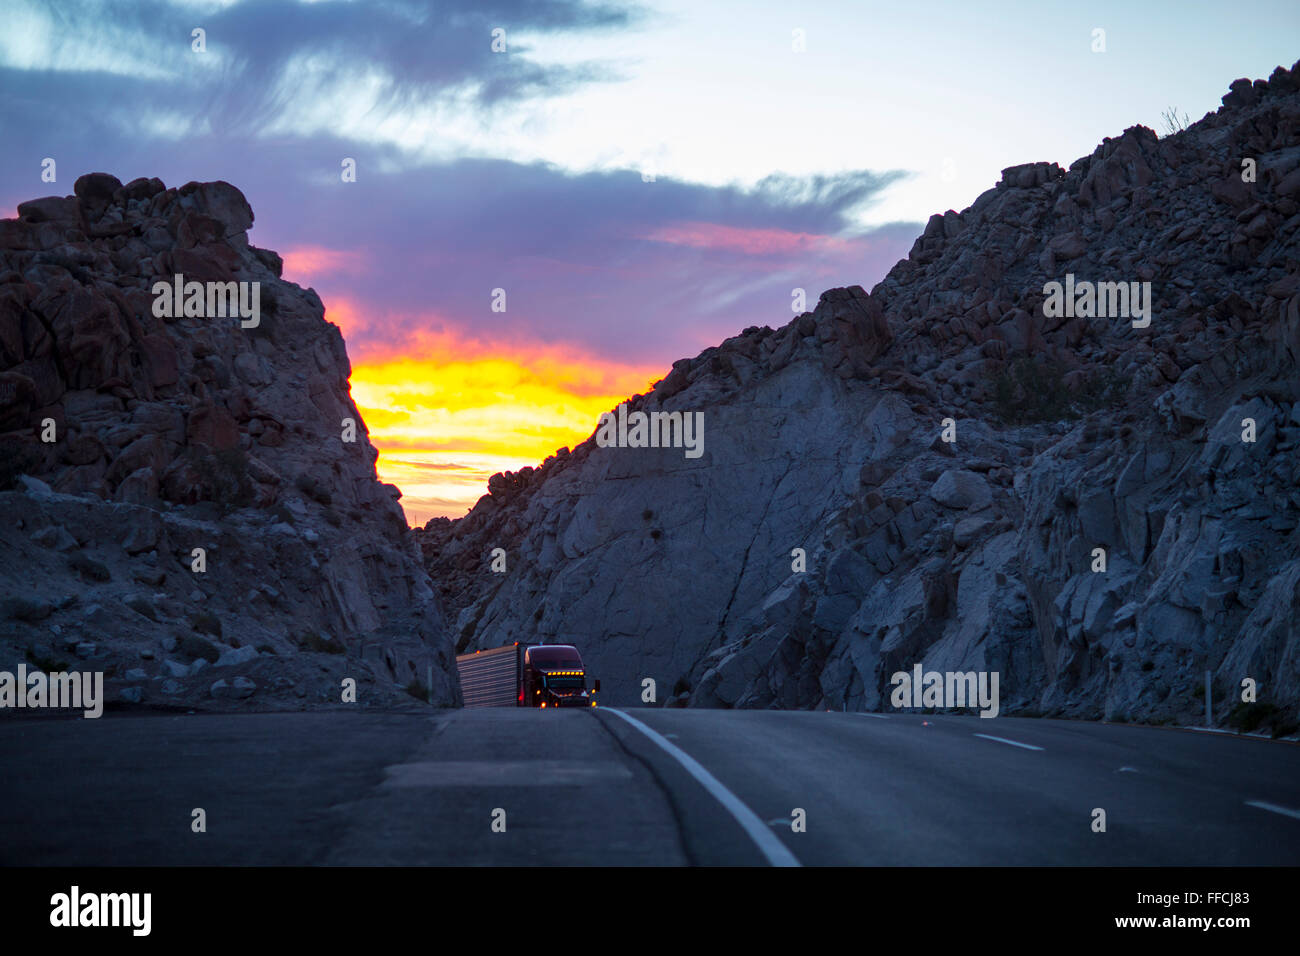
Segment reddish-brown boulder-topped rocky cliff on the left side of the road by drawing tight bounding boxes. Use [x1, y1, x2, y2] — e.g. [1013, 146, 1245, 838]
[0, 173, 459, 706]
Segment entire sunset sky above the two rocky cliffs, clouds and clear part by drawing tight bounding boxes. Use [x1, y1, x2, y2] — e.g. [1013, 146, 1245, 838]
[0, 0, 1300, 524]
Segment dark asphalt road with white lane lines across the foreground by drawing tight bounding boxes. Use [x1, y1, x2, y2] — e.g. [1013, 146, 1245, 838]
[0, 709, 1300, 866]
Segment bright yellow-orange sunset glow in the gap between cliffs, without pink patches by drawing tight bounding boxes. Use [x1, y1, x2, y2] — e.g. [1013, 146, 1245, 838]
[352, 334, 662, 524]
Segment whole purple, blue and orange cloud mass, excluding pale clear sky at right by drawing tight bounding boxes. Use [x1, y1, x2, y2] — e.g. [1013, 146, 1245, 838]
[0, 0, 918, 520]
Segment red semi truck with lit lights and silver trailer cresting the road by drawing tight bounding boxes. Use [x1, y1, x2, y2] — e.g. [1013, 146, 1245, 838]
[456, 644, 601, 708]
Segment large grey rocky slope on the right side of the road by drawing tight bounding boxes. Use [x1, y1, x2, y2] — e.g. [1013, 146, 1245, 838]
[423, 64, 1300, 727]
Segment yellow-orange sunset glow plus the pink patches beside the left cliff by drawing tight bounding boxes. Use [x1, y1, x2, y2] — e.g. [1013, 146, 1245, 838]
[283, 257, 668, 524]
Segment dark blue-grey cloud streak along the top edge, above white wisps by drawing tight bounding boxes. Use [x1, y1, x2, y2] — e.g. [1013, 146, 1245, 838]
[22, 0, 644, 118]
